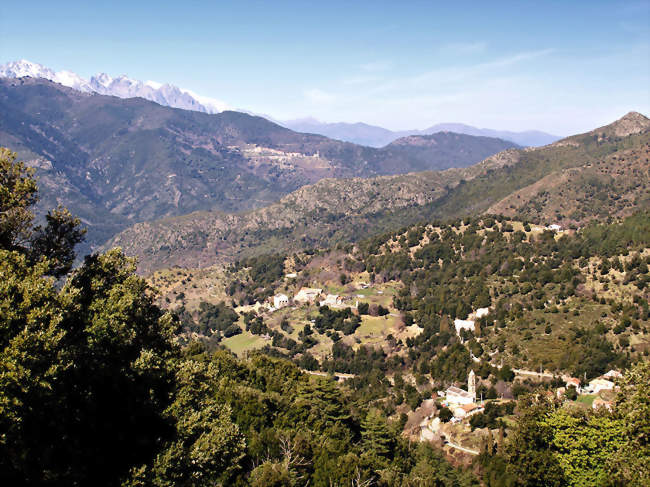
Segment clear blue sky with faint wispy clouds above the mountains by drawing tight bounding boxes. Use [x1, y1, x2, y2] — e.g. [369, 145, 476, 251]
[0, 0, 650, 135]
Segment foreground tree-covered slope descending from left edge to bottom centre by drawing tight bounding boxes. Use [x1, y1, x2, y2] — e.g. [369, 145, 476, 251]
[0, 150, 478, 487]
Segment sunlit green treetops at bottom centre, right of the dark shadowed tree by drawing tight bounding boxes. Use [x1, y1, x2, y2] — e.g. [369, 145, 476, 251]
[177, 352, 475, 487]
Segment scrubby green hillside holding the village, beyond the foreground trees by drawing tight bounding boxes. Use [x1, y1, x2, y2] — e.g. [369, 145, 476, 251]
[158, 211, 650, 486]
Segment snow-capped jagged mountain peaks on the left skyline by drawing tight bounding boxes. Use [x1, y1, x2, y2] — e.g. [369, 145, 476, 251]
[0, 59, 228, 113]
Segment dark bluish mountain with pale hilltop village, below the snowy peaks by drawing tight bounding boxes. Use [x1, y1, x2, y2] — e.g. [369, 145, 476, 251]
[0, 77, 516, 254]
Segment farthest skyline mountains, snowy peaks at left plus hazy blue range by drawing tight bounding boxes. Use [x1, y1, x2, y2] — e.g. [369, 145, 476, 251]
[0, 59, 560, 147]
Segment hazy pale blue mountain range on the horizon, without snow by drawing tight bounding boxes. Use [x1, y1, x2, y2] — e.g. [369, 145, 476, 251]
[278, 118, 561, 147]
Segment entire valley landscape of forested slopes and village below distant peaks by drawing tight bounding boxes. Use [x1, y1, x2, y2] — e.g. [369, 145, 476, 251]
[0, 67, 650, 487]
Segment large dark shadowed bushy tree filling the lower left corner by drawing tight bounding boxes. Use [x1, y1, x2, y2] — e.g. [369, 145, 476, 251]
[0, 251, 176, 485]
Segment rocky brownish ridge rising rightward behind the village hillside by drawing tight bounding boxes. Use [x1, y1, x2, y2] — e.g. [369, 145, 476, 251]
[106, 112, 650, 272]
